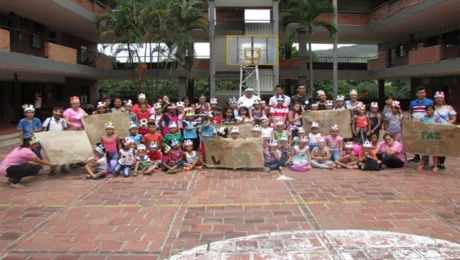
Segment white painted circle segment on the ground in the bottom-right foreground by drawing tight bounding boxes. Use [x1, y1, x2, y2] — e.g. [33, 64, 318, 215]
[170, 230, 460, 260]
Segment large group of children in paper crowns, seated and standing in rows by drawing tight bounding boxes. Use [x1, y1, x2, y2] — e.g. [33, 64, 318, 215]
[18, 89, 402, 179]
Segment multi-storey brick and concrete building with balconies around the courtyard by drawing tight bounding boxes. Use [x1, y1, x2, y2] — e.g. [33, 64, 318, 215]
[0, 0, 460, 123]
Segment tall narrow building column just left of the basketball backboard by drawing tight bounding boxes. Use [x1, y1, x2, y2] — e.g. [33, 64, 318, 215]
[208, 0, 216, 97]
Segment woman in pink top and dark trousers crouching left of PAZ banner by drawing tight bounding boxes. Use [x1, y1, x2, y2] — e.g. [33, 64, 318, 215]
[374, 133, 406, 168]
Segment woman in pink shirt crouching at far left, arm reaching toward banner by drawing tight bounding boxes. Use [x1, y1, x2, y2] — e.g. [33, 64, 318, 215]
[0, 137, 58, 188]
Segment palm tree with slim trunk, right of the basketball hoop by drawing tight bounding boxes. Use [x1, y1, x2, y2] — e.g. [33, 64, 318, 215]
[281, 0, 337, 98]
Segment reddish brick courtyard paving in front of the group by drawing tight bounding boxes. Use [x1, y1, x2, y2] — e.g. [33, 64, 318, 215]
[0, 143, 460, 260]
